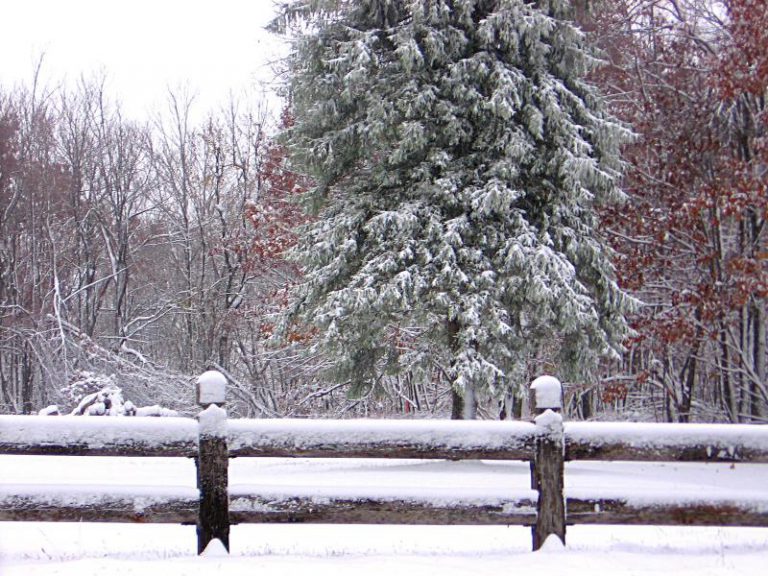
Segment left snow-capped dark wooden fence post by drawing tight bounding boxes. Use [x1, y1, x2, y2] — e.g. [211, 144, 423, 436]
[197, 370, 229, 554]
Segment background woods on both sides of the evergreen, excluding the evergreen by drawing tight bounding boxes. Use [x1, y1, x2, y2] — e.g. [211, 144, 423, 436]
[0, 0, 768, 422]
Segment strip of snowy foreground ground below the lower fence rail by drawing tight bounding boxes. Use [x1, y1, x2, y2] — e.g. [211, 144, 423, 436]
[0, 523, 768, 576]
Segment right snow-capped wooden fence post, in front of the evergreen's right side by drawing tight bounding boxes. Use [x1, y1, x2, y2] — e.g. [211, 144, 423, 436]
[531, 376, 565, 550]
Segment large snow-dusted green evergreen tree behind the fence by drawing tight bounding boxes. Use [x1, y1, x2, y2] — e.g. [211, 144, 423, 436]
[276, 0, 632, 417]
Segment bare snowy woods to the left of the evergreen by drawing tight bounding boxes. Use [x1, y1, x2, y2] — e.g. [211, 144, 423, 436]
[0, 73, 318, 413]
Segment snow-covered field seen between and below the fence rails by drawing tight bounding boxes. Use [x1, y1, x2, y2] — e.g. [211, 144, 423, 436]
[0, 456, 768, 576]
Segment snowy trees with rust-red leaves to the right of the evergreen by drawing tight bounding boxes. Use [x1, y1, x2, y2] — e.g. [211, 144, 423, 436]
[582, 0, 768, 422]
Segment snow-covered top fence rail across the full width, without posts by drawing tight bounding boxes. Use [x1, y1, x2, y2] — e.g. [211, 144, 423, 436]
[7, 416, 768, 463]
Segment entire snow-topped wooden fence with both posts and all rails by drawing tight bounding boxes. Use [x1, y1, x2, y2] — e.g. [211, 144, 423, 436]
[0, 372, 768, 551]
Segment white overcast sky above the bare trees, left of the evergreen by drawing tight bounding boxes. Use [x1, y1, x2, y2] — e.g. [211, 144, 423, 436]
[0, 0, 281, 117]
